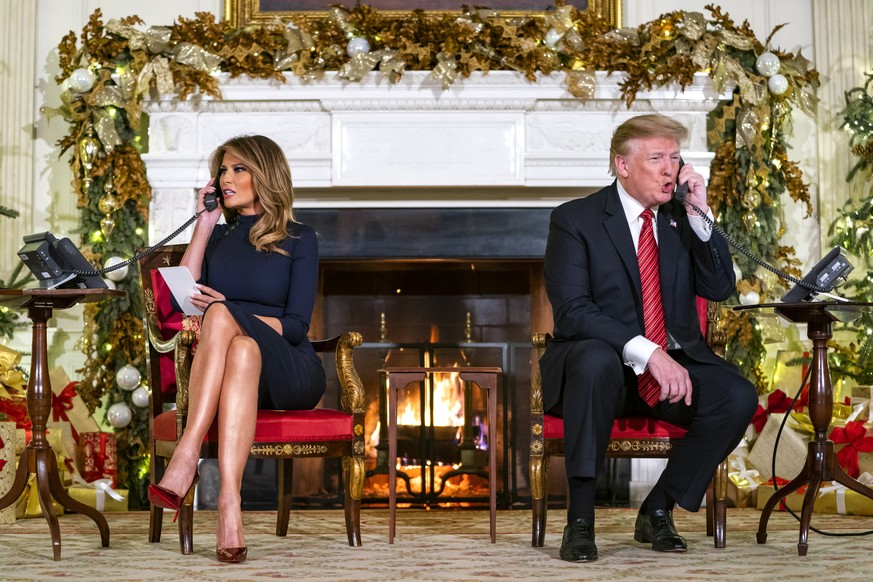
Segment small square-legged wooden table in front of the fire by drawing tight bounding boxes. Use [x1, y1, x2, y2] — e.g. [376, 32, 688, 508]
[385, 367, 502, 544]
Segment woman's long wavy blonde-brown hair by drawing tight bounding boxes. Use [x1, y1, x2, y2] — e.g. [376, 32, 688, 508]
[209, 135, 294, 255]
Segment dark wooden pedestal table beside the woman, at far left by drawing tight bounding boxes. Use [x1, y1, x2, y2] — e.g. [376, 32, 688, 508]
[0, 289, 125, 560]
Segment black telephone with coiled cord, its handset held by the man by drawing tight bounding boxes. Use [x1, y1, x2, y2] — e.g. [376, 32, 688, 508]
[673, 157, 855, 303]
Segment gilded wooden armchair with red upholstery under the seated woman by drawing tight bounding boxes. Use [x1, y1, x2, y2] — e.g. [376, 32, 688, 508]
[139, 245, 365, 554]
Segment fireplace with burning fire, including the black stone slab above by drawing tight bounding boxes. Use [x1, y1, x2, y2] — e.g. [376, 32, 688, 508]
[299, 208, 549, 507]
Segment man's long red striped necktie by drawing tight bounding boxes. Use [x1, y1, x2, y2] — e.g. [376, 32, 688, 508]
[637, 208, 667, 406]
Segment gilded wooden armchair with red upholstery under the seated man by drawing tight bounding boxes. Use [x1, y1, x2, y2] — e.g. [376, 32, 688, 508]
[530, 299, 728, 548]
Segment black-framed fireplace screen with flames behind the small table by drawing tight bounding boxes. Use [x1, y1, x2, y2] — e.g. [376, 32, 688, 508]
[362, 342, 512, 506]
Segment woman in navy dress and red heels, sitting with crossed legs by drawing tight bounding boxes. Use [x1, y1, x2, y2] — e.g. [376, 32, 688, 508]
[149, 135, 325, 562]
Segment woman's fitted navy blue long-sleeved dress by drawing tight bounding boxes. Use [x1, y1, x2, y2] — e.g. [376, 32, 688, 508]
[200, 215, 325, 410]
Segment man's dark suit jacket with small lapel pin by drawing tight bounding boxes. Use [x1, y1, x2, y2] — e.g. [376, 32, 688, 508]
[540, 182, 736, 411]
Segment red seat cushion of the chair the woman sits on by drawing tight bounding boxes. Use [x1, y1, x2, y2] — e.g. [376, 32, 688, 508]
[154, 408, 353, 443]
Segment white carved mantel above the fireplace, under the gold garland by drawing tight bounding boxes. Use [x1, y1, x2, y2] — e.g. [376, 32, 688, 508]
[143, 71, 727, 242]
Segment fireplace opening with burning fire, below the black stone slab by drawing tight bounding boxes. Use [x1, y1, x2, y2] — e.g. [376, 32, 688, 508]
[319, 260, 542, 507]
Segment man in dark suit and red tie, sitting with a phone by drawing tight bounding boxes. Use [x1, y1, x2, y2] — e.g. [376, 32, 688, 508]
[540, 115, 757, 562]
